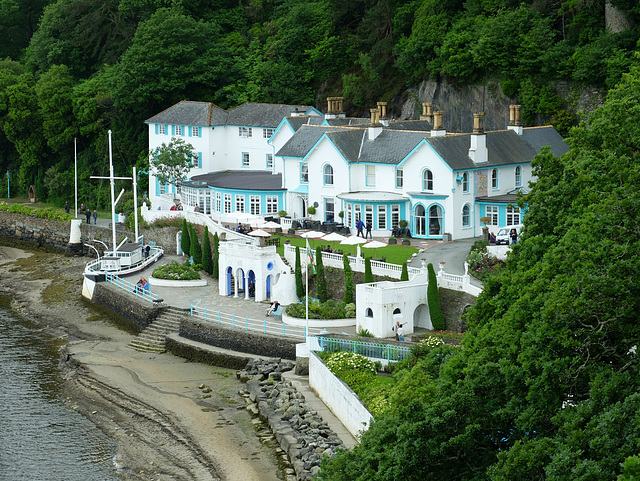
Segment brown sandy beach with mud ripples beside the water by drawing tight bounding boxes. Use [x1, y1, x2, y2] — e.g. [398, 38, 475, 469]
[0, 246, 280, 481]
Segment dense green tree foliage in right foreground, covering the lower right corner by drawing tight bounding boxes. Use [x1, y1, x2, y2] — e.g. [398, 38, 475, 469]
[321, 63, 640, 481]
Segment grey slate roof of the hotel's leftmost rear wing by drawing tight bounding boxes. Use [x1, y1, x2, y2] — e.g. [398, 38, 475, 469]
[146, 100, 321, 129]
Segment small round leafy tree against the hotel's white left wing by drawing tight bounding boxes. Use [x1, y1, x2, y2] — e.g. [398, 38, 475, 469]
[149, 138, 198, 191]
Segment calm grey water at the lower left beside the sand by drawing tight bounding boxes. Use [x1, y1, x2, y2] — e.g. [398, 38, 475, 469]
[0, 309, 120, 481]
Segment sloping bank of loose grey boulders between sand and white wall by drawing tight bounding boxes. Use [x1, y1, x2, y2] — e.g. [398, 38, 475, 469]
[238, 360, 344, 480]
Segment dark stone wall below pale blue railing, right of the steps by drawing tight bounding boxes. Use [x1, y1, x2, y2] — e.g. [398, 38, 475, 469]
[180, 319, 300, 360]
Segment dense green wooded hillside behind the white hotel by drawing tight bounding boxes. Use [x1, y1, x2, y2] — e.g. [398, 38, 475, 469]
[0, 0, 640, 202]
